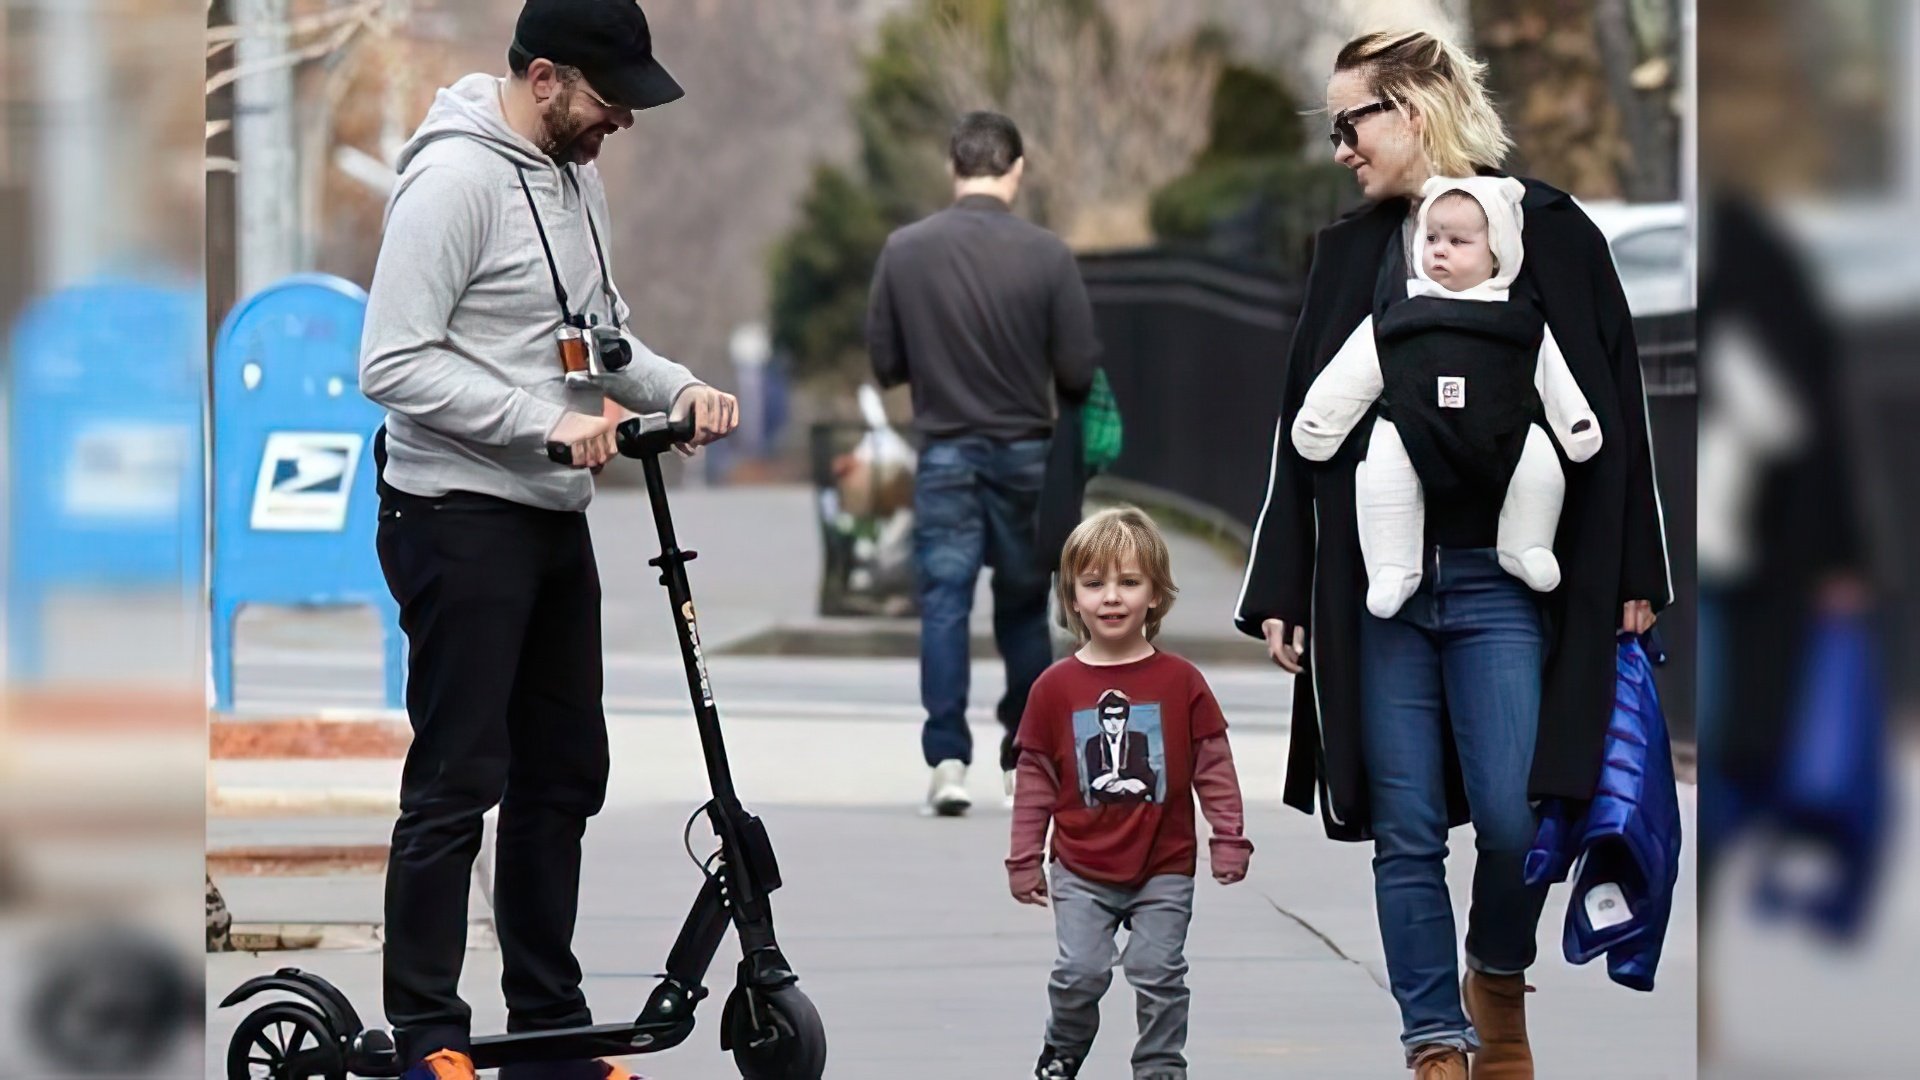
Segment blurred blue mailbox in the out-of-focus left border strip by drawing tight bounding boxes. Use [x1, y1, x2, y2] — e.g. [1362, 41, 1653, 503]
[6, 281, 205, 680]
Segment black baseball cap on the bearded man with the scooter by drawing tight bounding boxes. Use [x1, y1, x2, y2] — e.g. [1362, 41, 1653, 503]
[511, 0, 685, 110]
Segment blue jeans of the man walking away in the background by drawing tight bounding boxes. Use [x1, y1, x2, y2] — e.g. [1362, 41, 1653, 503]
[914, 434, 1054, 769]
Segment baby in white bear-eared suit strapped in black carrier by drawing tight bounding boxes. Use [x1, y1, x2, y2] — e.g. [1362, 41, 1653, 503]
[1292, 177, 1599, 619]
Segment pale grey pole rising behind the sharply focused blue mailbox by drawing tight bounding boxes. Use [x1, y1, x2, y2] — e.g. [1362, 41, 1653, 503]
[228, 0, 301, 296]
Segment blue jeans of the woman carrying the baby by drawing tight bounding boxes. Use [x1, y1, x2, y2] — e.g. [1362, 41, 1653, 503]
[1359, 548, 1546, 1055]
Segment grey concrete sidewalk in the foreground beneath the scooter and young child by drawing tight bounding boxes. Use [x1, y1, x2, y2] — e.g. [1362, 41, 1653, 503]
[207, 788, 1697, 1080]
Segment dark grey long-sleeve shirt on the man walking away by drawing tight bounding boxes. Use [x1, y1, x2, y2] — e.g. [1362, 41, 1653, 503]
[866, 196, 1100, 440]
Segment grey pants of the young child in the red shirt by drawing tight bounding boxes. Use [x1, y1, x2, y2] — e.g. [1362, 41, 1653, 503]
[1046, 863, 1194, 1080]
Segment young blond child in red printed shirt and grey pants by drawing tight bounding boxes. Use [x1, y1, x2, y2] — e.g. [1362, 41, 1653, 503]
[1006, 507, 1254, 1080]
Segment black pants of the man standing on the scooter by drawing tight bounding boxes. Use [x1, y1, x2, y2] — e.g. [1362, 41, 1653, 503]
[378, 490, 607, 1061]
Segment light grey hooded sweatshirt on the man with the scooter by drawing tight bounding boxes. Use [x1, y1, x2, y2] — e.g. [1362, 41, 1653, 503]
[361, 75, 697, 509]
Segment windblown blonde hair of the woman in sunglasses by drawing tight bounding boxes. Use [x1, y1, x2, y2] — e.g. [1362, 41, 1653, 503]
[1332, 31, 1513, 177]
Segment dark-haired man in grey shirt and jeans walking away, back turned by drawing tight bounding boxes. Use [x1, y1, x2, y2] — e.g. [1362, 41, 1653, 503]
[866, 111, 1100, 817]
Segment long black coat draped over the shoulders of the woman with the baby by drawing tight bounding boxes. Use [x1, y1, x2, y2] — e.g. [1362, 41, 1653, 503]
[1235, 181, 1672, 840]
